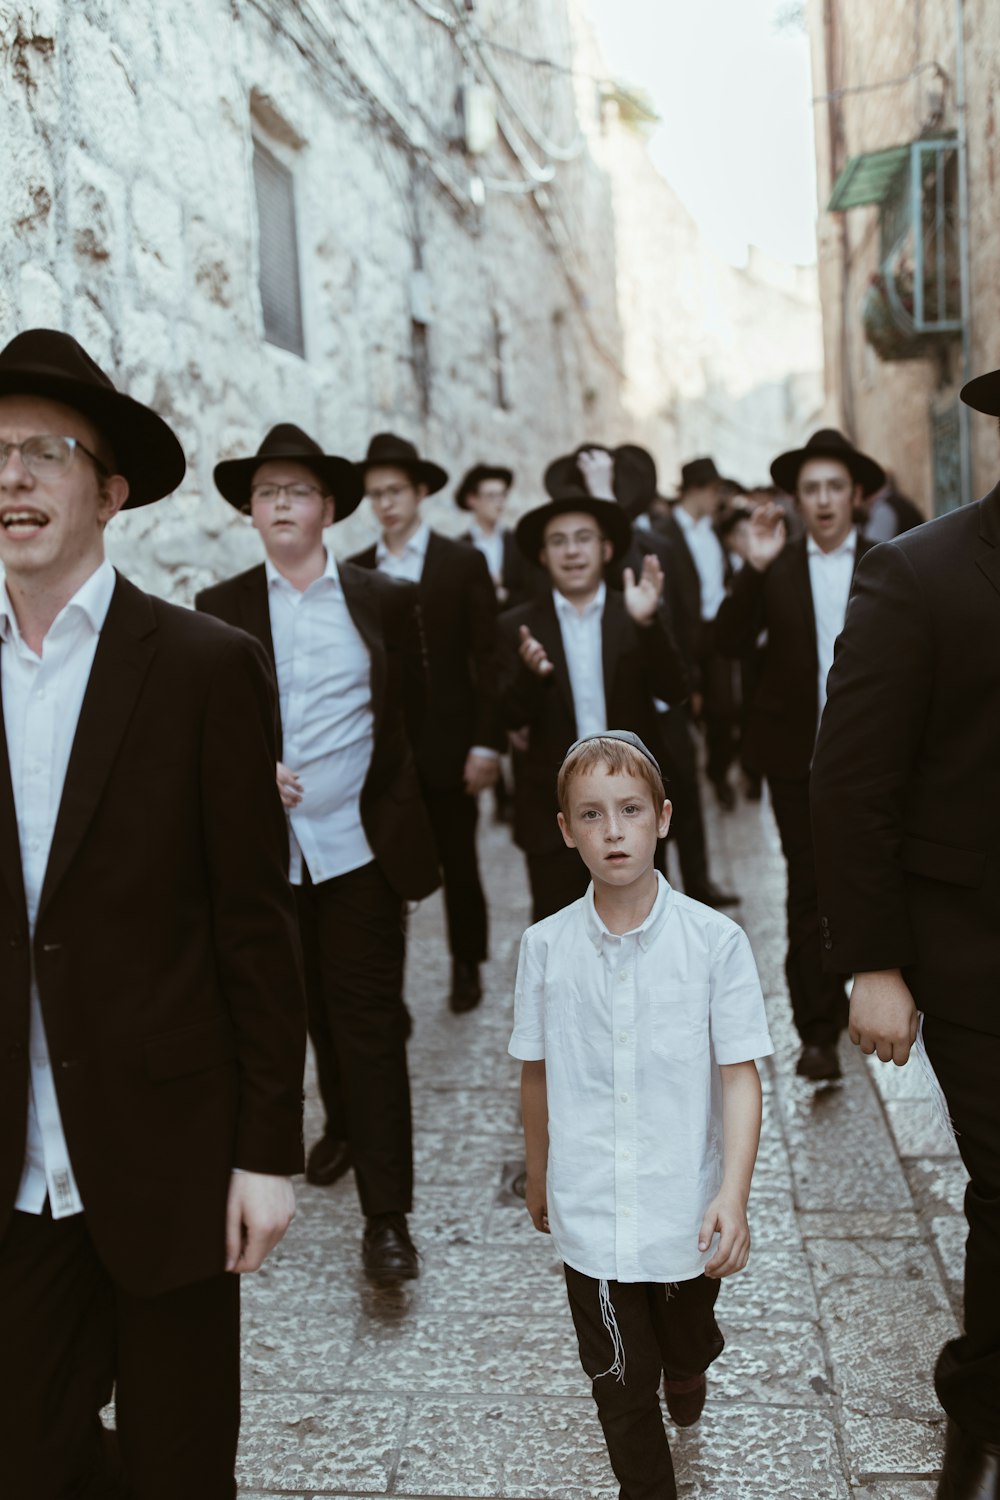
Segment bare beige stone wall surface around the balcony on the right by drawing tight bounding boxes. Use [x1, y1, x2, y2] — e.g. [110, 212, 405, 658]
[808, 0, 1000, 515]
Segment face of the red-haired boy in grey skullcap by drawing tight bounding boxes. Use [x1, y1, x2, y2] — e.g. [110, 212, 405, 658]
[559, 765, 670, 885]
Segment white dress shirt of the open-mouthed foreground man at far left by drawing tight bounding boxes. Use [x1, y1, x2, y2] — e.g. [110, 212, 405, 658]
[0, 560, 115, 1218]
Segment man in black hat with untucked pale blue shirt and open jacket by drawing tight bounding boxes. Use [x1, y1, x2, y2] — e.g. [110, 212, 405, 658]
[196, 423, 439, 1281]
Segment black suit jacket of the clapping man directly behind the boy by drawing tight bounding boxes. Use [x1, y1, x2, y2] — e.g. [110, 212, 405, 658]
[501, 588, 688, 854]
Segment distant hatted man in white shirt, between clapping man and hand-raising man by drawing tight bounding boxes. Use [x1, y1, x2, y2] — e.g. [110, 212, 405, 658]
[661, 459, 739, 812]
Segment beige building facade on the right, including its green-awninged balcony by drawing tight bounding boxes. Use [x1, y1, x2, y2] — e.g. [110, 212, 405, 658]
[808, 0, 1000, 515]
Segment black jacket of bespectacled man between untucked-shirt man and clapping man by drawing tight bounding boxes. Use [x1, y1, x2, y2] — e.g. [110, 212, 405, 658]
[352, 531, 501, 791]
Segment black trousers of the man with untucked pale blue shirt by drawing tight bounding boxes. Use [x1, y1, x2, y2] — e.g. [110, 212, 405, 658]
[295, 861, 414, 1215]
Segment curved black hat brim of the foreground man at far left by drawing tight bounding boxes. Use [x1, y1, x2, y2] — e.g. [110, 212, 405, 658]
[0, 369, 187, 510]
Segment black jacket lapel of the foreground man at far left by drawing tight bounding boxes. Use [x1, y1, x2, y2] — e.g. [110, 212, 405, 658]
[39, 575, 156, 918]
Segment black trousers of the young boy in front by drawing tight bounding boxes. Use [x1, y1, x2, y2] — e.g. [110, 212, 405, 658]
[564, 1266, 726, 1500]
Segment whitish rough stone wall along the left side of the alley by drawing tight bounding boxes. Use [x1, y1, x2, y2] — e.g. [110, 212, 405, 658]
[0, 0, 820, 602]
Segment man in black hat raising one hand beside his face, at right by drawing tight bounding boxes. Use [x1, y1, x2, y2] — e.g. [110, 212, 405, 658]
[715, 429, 883, 1082]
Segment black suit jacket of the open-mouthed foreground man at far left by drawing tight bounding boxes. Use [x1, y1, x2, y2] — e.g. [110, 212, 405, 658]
[0, 576, 306, 1295]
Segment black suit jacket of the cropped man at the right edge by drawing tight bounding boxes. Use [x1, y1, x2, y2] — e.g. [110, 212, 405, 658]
[811, 486, 1000, 1035]
